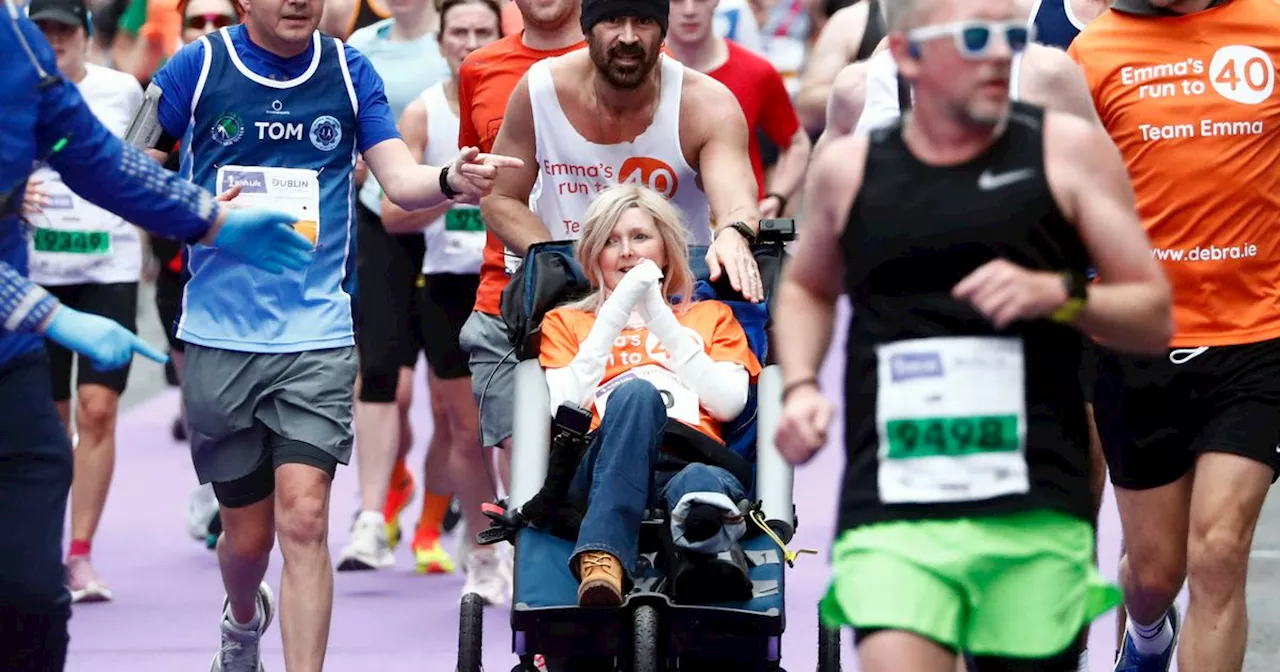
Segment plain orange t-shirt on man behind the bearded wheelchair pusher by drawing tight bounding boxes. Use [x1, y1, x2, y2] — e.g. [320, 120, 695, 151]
[458, 32, 586, 315]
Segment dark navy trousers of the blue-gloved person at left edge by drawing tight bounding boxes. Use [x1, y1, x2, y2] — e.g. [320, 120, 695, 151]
[0, 351, 72, 672]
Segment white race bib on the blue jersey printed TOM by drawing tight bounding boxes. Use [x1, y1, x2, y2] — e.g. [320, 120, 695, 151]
[218, 165, 323, 248]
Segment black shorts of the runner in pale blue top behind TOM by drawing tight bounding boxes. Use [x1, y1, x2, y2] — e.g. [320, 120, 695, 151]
[356, 204, 426, 403]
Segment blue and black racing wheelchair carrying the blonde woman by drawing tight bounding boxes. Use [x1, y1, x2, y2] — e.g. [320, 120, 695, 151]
[457, 219, 840, 672]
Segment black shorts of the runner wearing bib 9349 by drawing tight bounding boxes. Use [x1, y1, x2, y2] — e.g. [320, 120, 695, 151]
[45, 283, 138, 402]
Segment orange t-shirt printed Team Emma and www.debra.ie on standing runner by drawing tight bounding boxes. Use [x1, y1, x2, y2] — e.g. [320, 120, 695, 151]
[1069, 0, 1280, 347]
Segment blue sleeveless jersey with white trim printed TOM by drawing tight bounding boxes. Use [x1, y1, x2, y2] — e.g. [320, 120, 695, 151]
[178, 27, 360, 352]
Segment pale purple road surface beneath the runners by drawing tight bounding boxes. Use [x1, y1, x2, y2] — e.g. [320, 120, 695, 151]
[60, 302, 1177, 672]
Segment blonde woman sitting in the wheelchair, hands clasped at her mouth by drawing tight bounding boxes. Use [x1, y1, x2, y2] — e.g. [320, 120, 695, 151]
[539, 184, 760, 607]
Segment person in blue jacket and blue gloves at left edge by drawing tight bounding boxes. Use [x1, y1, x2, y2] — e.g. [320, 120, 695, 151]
[0, 0, 311, 672]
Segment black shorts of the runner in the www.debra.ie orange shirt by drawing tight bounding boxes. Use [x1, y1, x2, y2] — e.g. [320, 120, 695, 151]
[1093, 339, 1280, 490]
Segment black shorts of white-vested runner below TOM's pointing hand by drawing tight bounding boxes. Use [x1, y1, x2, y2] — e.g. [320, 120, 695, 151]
[422, 273, 480, 380]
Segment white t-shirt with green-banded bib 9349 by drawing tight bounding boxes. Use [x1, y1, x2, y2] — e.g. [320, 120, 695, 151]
[27, 64, 142, 287]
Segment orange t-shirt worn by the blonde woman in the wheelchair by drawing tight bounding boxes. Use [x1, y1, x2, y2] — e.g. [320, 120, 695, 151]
[538, 301, 760, 443]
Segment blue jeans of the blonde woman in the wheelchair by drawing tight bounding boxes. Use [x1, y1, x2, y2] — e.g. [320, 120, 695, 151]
[570, 380, 746, 577]
